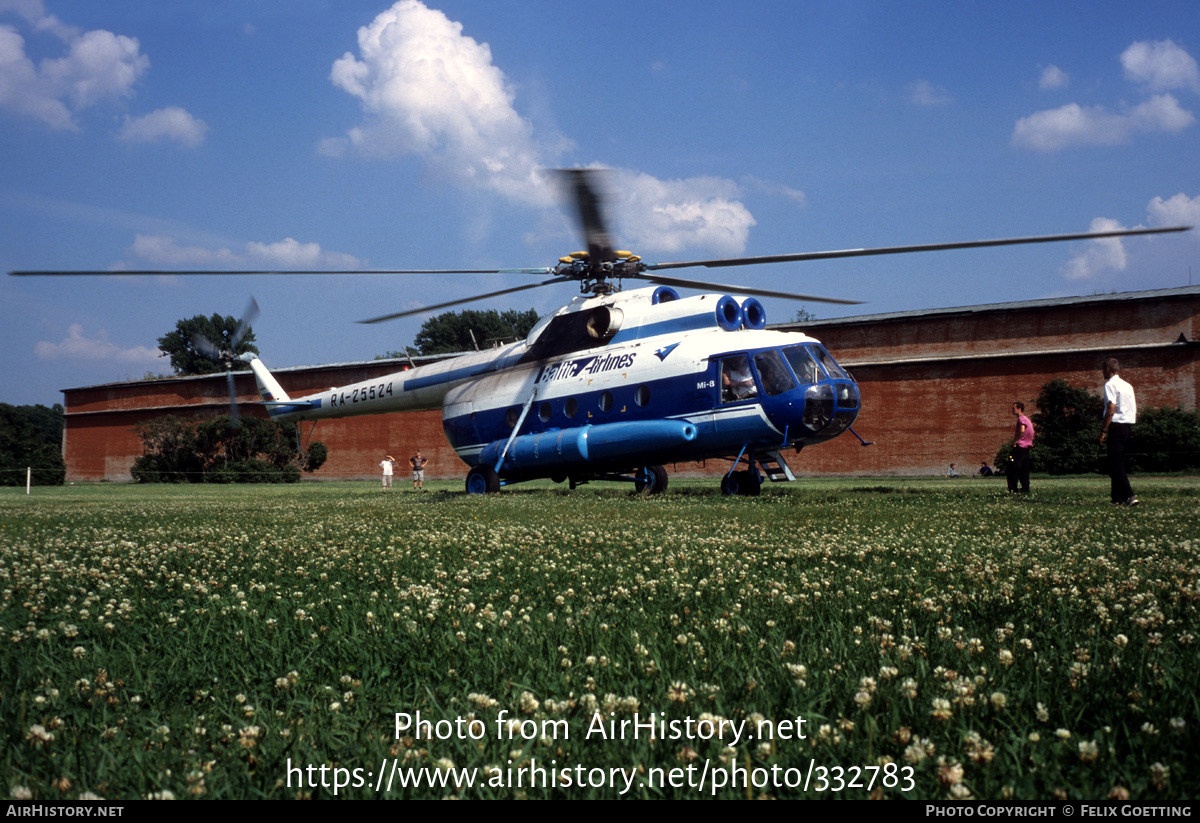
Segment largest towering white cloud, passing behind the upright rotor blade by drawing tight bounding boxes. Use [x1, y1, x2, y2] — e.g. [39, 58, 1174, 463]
[317, 0, 758, 254]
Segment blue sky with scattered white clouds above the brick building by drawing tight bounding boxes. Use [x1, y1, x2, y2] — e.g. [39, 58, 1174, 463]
[0, 0, 1200, 404]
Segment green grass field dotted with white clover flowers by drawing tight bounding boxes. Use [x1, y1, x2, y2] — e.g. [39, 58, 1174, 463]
[0, 477, 1200, 800]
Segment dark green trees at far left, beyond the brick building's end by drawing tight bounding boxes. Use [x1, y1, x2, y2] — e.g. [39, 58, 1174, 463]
[0, 403, 67, 486]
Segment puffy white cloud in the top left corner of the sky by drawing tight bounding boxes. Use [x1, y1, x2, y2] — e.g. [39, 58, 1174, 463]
[0, 0, 150, 130]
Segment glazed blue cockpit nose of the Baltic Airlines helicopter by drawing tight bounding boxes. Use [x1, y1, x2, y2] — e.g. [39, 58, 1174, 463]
[718, 343, 858, 443]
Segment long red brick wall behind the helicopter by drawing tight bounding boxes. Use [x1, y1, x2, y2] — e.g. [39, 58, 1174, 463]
[64, 289, 1200, 480]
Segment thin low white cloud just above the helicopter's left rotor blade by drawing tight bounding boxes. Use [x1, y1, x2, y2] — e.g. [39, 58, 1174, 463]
[121, 234, 364, 270]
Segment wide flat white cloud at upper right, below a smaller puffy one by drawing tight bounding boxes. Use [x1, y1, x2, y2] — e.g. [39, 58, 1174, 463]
[1013, 95, 1195, 151]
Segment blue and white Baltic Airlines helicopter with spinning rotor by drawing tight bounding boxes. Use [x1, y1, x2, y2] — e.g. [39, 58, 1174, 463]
[11, 169, 1190, 495]
